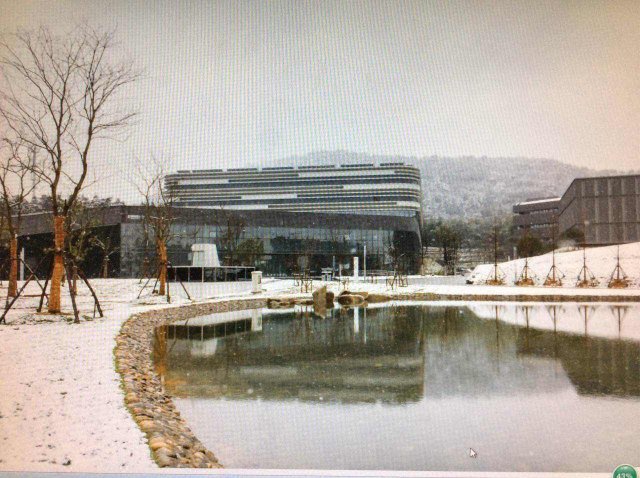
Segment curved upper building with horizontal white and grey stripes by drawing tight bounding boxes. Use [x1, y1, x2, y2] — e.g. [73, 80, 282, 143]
[165, 163, 421, 217]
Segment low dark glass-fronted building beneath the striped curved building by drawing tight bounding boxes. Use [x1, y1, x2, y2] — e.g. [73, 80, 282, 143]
[19, 206, 421, 277]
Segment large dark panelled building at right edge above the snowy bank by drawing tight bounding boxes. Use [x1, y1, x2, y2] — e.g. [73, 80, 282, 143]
[558, 174, 640, 246]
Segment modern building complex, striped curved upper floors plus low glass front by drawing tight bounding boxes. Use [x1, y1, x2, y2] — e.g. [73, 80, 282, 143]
[13, 163, 422, 277]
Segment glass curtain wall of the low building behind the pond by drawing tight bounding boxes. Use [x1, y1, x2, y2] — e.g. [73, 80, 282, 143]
[120, 222, 412, 277]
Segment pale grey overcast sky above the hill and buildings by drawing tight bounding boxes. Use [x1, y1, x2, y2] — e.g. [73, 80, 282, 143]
[0, 0, 640, 200]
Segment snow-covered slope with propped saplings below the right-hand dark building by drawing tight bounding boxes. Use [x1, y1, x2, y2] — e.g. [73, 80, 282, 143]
[470, 242, 640, 288]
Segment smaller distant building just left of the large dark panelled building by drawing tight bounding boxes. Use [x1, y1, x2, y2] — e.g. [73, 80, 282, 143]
[513, 197, 560, 242]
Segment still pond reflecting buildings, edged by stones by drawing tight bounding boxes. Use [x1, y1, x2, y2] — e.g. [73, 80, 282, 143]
[154, 303, 640, 473]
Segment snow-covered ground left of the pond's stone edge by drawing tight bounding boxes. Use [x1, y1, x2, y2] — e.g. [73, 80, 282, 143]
[0, 279, 292, 472]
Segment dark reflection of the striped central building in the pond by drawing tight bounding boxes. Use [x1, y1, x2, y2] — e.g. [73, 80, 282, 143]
[160, 310, 424, 402]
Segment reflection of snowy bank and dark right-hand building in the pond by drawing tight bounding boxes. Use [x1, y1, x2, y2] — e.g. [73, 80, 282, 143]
[470, 304, 640, 397]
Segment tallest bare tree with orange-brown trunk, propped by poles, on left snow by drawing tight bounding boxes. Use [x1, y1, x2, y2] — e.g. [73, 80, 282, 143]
[0, 27, 139, 313]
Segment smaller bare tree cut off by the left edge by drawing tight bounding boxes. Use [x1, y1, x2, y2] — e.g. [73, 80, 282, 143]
[0, 138, 36, 297]
